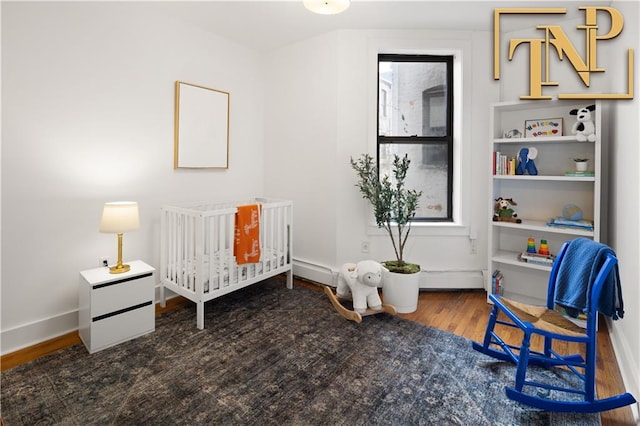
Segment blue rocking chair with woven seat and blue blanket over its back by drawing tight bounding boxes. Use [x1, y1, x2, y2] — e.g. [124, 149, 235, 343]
[472, 238, 635, 413]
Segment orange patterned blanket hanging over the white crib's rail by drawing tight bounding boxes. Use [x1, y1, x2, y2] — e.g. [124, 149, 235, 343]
[233, 204, 260, 265]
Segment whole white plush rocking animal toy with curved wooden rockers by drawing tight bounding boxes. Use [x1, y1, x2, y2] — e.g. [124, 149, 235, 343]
[325, 260, 396, 322]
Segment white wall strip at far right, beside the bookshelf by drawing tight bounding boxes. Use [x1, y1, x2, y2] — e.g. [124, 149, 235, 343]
[607, 1, 640, 412]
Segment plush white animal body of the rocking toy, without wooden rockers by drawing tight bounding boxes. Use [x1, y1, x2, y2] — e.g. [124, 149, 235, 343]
[336, 260, 382, 314]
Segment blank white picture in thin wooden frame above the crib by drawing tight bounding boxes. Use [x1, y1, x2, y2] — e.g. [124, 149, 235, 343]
[173, 81, 229, 169]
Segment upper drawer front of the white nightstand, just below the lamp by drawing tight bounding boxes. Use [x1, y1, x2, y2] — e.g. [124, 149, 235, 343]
[91, 274, 154, 318]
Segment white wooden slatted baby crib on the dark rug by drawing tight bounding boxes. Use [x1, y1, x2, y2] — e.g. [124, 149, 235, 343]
[159, 198, 293, 330]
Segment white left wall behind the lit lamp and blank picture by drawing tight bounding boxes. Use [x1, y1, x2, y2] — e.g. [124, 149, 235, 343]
[1, 2, 264, 353]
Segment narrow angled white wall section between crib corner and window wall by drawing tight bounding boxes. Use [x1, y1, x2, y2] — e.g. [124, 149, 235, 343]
[264, 34, 339, 274]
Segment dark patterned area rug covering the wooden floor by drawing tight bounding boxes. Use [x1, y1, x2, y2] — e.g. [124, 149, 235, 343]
[2, 279, 600, 426]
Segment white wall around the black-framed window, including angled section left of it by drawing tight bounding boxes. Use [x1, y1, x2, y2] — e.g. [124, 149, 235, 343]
[265, 30, 498, 288]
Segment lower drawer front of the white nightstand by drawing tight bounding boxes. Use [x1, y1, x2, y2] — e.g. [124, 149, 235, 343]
[91, 303, 155, 353]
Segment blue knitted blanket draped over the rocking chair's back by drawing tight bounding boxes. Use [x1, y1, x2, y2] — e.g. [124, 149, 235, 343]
[555, 238, 624, 320]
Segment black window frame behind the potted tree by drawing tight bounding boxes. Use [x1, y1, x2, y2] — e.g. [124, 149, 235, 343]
[376, 53, 454, 222]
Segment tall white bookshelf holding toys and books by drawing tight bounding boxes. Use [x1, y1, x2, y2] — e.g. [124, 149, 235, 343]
[486, 100, 606, 303]
